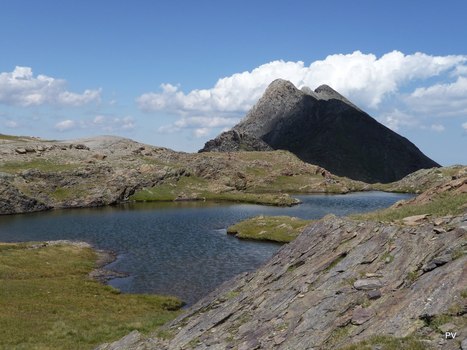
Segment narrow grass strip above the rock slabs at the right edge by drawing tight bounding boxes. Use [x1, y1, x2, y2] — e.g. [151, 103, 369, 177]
[350, 193, 467, 221]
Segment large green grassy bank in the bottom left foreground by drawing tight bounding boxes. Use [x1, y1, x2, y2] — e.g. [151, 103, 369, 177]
[0, 243, 181, 349]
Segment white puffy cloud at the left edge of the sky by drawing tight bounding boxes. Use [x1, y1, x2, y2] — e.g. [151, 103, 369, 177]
[0, 67, 101, 107]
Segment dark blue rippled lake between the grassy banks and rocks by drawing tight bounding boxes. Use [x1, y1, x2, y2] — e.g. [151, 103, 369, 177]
[0, 192, 410, 304]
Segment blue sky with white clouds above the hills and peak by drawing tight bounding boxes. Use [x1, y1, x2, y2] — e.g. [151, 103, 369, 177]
[0, 0, 467, 165]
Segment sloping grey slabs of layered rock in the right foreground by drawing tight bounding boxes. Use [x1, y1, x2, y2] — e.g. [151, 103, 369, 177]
[100, 213, 467, 350]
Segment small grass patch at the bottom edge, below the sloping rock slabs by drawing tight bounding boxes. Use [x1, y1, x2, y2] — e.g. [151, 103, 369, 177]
[340, 335, 429, 350]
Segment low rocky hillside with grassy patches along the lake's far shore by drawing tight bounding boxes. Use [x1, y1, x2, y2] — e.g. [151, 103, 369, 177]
[0, 135, 366, 214]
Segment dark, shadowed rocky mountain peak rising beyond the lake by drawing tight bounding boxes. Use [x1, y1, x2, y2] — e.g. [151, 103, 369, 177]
[200, 79, 439, 183]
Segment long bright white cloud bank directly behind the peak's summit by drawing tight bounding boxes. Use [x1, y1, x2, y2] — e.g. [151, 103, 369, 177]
[137, 51, 467, 115]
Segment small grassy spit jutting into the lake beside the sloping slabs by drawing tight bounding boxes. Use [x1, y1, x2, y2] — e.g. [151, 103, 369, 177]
[227, 216, 312, 243]
